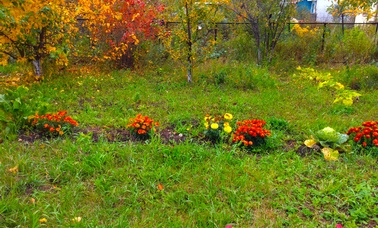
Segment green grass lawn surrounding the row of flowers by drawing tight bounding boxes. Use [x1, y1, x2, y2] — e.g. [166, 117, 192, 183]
[0, 61, 378, 227]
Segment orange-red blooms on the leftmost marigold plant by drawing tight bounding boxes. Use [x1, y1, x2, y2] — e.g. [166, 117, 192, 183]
[31, 111, 79, 135]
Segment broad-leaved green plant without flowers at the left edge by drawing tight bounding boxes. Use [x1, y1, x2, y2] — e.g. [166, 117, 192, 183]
[0, 86, 48, 137]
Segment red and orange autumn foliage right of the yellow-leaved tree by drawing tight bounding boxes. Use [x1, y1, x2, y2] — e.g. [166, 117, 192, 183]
[78, 0, 164, 60]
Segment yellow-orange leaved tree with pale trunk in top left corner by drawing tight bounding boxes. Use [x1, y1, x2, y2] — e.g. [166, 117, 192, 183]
[0, 0, 77, 76]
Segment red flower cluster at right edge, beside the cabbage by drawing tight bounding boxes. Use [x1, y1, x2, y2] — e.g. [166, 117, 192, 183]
[347, 121, 378, 147]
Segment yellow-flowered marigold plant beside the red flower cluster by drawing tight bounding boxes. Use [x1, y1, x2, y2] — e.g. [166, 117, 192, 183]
[204, 113, 233, 143]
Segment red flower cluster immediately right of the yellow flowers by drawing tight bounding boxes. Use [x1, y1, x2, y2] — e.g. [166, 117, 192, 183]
[232, 120, 270, 146]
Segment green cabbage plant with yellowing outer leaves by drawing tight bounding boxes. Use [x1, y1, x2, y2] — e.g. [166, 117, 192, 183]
[304, 127, 349, 161]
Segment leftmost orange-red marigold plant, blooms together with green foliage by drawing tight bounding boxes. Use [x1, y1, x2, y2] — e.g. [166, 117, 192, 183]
[29, 111, 79, 137]
